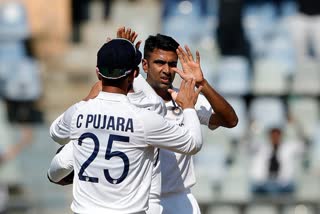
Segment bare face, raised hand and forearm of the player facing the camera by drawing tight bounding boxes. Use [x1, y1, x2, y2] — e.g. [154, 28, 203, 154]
[142, 46, 238, 129]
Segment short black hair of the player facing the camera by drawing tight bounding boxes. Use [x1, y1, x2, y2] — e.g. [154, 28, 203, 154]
[143, 33, 179, 59]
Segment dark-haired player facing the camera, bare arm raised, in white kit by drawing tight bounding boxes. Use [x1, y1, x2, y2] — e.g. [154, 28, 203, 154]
[134, 34, 238, 214]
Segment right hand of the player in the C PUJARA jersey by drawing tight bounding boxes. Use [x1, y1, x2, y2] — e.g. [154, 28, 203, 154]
[168, 79, 202, 109]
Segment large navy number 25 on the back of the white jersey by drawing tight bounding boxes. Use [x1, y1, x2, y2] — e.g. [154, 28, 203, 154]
[78, 132, 129, 184]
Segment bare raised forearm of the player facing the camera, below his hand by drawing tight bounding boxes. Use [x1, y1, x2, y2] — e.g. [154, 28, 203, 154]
[201, 80, 238, 128]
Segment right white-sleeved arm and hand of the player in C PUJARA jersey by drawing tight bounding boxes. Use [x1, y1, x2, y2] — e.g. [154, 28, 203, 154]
[144, 80, 202, 154]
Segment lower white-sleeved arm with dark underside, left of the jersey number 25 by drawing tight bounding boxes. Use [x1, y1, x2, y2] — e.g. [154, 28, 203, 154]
[47, 143, 74, 185]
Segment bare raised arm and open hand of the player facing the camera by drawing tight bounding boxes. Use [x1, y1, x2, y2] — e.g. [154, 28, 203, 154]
[175, 46, 238, 129]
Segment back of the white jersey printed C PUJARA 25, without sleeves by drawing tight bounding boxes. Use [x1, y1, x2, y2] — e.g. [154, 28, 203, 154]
[71, 93, 154, 214]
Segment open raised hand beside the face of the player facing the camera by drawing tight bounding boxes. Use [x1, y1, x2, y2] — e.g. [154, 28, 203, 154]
[173, 45, 204, 86]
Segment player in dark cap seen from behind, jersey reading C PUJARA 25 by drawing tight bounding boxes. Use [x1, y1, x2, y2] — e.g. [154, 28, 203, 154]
[50, 39, 202, 214]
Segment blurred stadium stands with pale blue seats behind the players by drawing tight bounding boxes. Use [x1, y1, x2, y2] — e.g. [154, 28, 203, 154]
[0, 0, 320, 214]
